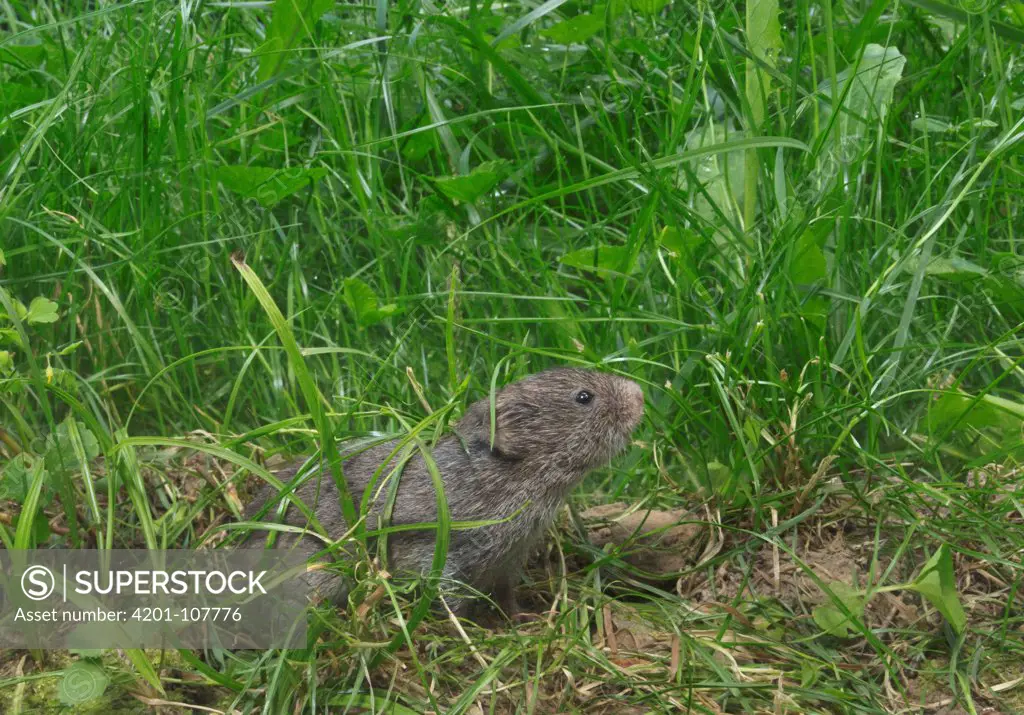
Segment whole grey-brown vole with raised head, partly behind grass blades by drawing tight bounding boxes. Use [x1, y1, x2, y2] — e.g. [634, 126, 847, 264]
[246, 368, 644, 617]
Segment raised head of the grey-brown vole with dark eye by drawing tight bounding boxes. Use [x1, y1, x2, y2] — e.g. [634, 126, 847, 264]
[457, 368, 643, 475]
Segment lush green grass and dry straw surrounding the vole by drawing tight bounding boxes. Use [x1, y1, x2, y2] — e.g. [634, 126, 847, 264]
[0, 0, 1024, 713]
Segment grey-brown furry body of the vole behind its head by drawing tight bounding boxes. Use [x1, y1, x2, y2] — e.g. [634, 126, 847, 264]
[246, 436, 562, 599]
